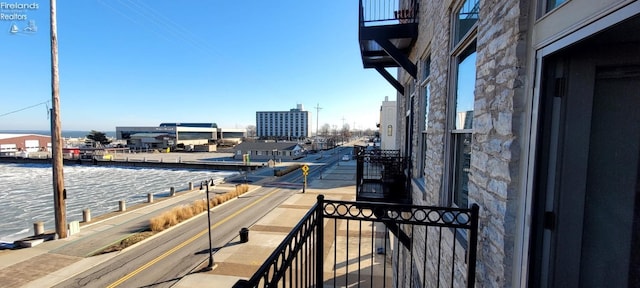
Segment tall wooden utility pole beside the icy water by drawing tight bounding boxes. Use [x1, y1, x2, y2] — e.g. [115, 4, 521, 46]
[50, 0, 67, 238]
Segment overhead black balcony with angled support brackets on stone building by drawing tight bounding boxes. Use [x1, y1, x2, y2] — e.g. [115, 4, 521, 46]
[358, 0, 419, 94]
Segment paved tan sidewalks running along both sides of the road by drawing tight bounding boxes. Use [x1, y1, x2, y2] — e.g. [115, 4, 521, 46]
[0, 150, 382, 287]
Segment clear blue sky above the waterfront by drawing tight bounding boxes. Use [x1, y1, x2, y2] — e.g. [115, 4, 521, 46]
[0, 0, 396, 131]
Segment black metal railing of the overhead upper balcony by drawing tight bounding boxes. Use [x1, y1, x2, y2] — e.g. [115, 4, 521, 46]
[360, 0, 418, 26]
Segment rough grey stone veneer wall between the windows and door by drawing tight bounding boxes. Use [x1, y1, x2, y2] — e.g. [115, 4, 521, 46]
[398, 0, 531, 287]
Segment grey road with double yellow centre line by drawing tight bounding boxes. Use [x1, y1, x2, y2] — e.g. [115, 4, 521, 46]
[56, 148, 346, 287]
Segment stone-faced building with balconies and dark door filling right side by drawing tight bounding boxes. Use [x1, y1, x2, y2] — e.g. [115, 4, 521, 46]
[354, 0, 640, 287]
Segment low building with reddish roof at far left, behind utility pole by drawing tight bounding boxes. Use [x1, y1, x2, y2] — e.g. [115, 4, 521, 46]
[0, 134, 51, 156]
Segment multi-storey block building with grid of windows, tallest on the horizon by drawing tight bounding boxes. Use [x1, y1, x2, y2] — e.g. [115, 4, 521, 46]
[256, 104, 311, 140]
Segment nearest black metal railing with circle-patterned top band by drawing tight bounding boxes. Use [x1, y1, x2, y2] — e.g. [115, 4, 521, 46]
[234, 195, 479, 288]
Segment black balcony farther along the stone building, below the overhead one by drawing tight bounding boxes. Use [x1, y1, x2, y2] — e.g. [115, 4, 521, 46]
[355, 147, 411, 204]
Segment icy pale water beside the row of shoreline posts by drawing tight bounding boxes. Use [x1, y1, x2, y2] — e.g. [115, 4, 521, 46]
[0, 164, 237, 243]
